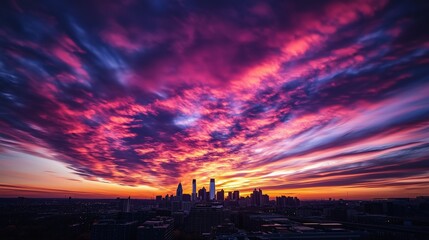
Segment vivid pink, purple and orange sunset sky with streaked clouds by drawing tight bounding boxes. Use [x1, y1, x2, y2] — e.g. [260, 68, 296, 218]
[0, 0, 429, 199]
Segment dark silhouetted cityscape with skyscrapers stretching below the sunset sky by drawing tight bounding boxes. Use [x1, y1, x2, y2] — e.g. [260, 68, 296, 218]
[0, 179, 429, 240]
